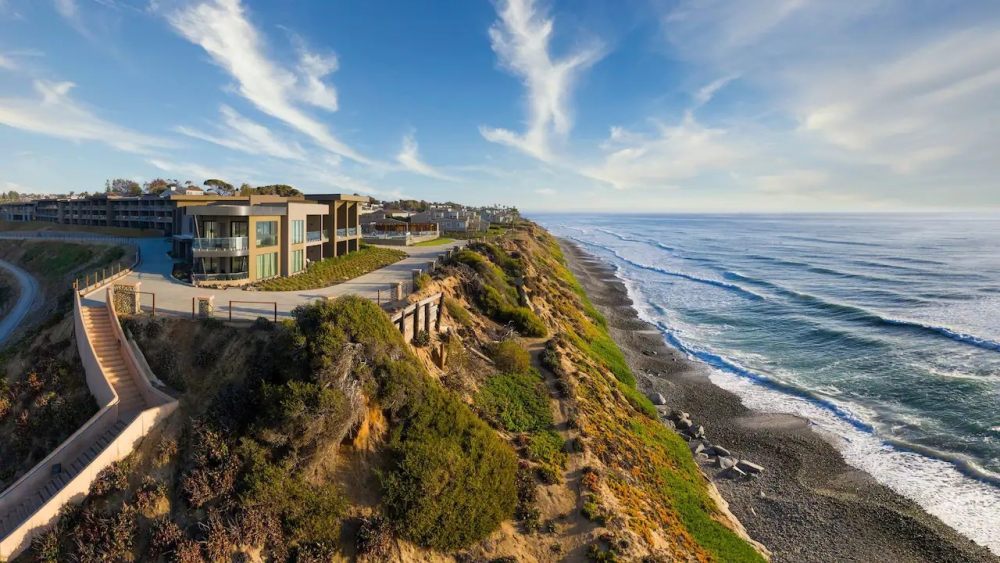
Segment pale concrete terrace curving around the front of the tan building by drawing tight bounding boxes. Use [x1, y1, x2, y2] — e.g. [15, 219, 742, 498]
[0, 232, 466, 320]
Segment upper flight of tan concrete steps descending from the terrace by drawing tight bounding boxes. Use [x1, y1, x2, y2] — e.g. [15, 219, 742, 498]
[81, 305, 146, 421]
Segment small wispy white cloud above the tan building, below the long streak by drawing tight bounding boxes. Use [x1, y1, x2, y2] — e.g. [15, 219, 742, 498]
[176, 105, 306, 160]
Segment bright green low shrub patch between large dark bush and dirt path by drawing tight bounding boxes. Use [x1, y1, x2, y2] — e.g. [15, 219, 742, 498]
[476, 372, 552, 432]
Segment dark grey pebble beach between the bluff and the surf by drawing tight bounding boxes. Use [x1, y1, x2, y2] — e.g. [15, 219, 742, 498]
[559, 239, 1000, 561]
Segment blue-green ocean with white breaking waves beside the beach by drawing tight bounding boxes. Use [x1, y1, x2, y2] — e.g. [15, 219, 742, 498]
[532, 214, 1000, 553]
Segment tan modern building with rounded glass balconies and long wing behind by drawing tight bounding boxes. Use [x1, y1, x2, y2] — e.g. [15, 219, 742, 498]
[0, 192, 370, 284]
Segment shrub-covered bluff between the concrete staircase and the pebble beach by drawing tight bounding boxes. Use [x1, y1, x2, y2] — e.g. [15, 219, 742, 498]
[15, 224, 762, 561]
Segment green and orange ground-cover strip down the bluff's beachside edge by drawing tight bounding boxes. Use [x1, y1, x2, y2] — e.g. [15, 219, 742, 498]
[488, 226, 761, 561]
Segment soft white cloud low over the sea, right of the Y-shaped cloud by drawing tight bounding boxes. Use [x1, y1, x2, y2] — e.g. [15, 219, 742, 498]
[583, 112, 746, 189]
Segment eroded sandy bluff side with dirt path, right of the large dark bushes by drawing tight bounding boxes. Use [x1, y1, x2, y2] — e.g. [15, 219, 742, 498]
[406, 224, 762, 561]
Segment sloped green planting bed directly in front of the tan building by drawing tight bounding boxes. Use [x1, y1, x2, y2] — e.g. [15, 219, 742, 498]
[255, 246, 406, 291]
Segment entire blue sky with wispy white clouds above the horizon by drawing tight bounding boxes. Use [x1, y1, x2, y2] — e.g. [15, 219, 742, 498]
[0, 0, 1000, 212]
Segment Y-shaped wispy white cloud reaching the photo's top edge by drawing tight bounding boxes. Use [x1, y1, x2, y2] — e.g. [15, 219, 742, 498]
[480, 0, 601, 161]
